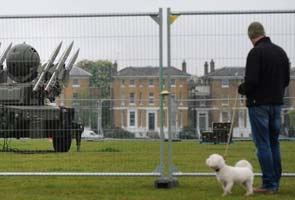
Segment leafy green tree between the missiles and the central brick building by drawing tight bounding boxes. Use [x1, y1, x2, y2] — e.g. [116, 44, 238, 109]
[77, 60, 115, 99]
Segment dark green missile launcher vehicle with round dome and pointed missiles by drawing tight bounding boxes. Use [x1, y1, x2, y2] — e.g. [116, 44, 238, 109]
[0, 42, 83, 152]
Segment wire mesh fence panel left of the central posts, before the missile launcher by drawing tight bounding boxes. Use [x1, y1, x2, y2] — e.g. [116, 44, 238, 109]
[0, 12, 161, 176]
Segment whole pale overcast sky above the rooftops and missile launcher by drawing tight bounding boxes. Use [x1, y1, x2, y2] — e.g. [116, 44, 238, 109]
[0, 0, 295, 75]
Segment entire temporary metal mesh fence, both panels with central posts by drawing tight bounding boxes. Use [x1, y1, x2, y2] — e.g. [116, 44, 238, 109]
[0, 9, 295, 184]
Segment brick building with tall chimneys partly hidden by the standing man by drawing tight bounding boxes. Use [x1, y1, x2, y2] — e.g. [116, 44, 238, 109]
[191, 60, 250, 137]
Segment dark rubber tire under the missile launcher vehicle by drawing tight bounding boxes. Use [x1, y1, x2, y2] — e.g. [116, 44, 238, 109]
[52, 133, 72, 152]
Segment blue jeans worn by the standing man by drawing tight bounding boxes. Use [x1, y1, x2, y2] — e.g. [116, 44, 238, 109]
[248, 105, 282, 190]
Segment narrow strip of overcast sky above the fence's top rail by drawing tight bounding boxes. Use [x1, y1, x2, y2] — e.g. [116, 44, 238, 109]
[0, 0, 295, 15]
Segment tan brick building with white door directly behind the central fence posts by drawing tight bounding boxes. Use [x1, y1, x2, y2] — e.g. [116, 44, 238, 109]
[112, 62, 190, 137]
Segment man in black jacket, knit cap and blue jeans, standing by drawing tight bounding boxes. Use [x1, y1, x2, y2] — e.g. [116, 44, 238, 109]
[238, 22, 290, 193]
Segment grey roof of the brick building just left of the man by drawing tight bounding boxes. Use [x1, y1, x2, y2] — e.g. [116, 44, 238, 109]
[203, 67, 245, 79]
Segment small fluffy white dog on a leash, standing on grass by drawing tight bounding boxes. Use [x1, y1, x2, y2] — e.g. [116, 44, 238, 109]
[206, 154, 254, 196]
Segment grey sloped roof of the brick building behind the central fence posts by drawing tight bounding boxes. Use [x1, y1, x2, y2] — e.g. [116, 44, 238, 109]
[116, 66, 190, 77]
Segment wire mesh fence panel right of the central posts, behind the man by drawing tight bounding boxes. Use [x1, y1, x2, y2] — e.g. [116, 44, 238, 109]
[168, 11, 295, 176]
